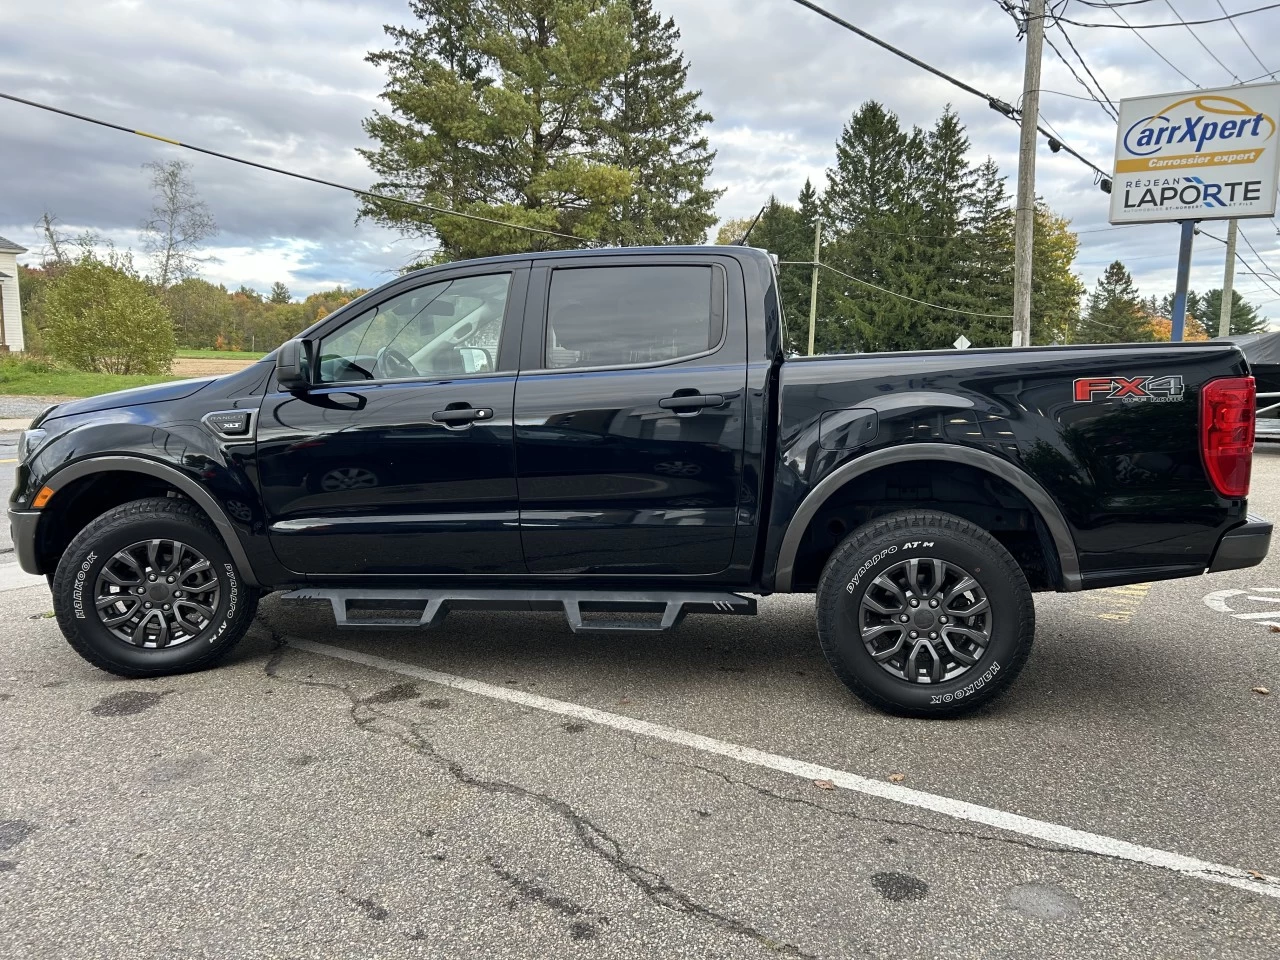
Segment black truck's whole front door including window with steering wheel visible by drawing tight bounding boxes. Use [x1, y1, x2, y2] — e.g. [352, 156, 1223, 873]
[257, 268, 529, 576]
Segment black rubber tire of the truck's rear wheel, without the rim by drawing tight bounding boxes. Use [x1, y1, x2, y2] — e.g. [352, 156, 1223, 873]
[819, 527, 1034, 714]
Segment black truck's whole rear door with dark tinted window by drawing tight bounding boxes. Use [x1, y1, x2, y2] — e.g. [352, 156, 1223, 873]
[516, 255, 746, 577]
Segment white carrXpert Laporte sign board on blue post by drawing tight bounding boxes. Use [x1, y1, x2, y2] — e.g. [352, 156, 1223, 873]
[1111, 83, 1280, 223]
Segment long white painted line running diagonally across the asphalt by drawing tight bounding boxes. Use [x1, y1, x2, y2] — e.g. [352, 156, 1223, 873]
[288, 639, 1280, 899]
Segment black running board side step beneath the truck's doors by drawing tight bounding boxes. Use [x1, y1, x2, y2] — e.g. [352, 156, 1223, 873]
[282, 588, 755, 634]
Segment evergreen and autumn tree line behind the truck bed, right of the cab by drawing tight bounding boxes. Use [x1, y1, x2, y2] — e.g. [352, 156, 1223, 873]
[717, 101, 1266, 353]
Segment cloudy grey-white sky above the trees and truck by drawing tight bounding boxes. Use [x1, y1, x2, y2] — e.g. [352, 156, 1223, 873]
[0, 0, 1280, 317]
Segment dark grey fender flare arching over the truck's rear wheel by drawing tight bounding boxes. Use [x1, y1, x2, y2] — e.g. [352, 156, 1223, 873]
[774, 443, 1083, 593]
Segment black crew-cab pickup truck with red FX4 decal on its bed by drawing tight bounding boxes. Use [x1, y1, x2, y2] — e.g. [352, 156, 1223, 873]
[9, 247, 1271, 717]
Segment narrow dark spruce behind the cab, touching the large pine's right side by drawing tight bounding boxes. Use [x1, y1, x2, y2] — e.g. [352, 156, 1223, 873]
[596, 0, 724, 246]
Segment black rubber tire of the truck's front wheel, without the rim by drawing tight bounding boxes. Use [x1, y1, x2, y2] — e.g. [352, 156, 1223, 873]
[54, 517, 250, 673]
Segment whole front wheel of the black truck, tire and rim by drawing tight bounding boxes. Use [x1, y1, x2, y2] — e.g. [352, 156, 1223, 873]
[52, 497, 257, 677]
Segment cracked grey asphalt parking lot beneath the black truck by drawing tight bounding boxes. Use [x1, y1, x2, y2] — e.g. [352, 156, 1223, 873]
[0, 435, 1280, 957]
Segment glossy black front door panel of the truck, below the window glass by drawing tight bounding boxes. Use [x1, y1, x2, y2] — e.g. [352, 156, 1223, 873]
[257, 376, 525, 575]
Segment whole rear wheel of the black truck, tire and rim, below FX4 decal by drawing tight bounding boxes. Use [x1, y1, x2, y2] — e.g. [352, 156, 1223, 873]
[818, 511, 1036, 717]
